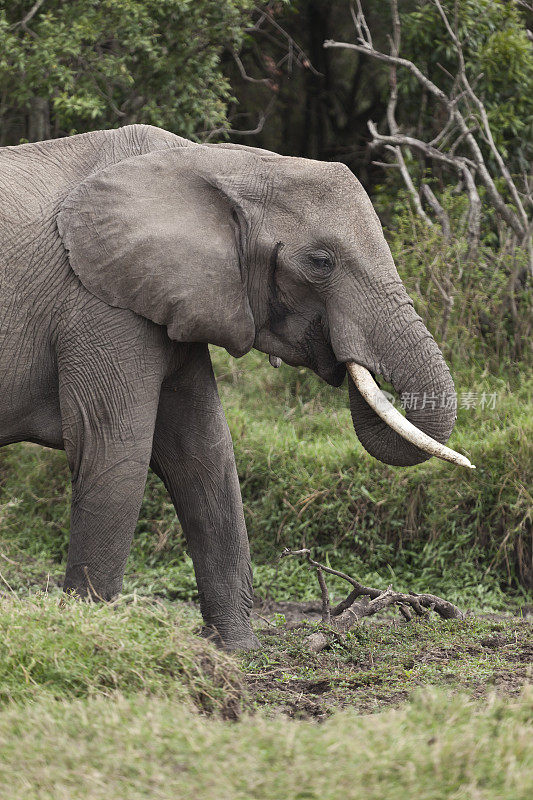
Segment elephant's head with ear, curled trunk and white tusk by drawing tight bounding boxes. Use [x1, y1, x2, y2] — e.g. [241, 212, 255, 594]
[58, 145, 469, 465]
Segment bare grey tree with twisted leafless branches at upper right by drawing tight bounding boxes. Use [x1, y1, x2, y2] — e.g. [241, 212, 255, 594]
[324, 0, 533, 274]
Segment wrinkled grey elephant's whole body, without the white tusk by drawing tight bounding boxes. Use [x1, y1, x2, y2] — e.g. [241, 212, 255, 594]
[0, 125, 454, 648]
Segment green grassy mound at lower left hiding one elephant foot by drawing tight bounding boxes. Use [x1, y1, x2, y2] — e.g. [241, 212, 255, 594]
[0, 594, 243, 716]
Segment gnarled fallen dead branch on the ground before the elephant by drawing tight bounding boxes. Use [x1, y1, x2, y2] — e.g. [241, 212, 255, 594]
[281, 547, 464, 653]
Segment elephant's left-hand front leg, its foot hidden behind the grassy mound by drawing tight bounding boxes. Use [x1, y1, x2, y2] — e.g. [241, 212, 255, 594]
[58, 312, 164, 600]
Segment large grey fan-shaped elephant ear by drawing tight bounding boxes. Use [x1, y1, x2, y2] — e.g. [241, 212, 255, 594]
[57, 145, 255, 356]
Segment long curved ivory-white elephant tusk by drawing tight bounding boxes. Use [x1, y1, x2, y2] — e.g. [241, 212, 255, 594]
[346, 361, 475, 469]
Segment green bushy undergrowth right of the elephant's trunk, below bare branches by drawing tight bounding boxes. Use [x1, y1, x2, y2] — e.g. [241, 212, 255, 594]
[373, 188, 533, 372]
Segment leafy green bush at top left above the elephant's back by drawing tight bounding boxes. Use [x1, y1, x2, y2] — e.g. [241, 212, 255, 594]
[0, 0, 252, 144]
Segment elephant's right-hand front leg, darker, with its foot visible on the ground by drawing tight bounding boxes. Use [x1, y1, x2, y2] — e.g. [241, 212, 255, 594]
[151, 345, 258, 649]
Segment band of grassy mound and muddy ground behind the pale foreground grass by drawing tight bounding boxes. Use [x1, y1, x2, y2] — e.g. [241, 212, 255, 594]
[0, 590, 533, 716]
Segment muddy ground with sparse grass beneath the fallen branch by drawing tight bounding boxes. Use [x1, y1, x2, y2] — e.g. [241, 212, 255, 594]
[243, 602, 533, 720]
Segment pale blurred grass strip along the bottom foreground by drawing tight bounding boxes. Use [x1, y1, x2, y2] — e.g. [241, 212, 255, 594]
[0, 691, 533, 800]
